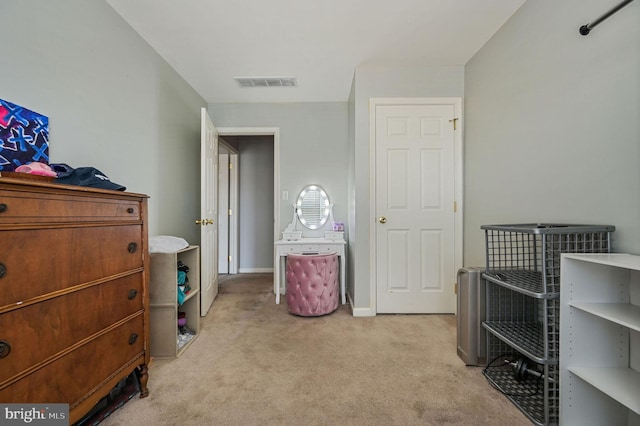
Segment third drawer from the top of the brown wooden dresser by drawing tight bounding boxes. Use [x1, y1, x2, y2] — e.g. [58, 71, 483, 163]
[0, 273, 144, 383]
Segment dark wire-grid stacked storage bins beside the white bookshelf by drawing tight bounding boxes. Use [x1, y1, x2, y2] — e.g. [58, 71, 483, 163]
[481, 223, 615, 425]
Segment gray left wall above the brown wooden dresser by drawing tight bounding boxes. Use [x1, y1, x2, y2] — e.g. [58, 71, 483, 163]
[0, 0, 206, 244]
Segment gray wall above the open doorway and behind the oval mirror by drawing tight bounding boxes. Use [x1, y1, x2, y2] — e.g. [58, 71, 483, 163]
[208, 102, 347, 243]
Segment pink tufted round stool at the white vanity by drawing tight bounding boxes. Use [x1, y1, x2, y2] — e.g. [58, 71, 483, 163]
[286, 253, 340, 317]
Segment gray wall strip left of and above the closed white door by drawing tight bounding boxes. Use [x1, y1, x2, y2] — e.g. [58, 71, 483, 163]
[349, 66, 464, 315]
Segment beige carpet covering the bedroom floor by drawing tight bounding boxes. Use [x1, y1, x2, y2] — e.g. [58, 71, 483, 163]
[102, 274, 531, 426]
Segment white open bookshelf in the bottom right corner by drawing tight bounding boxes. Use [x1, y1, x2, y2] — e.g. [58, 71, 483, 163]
[560, 254, 640, 426]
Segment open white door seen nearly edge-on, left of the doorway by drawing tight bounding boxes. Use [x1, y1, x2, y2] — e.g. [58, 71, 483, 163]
[199, 108, 218, 316]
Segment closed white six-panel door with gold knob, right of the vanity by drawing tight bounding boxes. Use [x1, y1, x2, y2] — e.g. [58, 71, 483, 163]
[374, 105, 456, 313]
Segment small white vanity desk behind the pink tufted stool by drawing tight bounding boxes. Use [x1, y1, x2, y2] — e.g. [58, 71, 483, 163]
[273, 238, 347, 305]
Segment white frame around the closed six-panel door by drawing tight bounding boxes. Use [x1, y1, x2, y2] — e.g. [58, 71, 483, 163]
[369, 97, 464, 315]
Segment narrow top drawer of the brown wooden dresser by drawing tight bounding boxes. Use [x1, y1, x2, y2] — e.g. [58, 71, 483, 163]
[0, 189, 141, 224]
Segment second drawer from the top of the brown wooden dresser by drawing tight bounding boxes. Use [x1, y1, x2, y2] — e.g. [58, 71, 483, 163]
[0, 225, 145, 304]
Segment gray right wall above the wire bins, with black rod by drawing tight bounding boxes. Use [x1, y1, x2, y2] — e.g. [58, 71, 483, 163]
[464, 0, 640, 266]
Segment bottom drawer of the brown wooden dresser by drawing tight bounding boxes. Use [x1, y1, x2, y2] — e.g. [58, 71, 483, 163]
[0, 313, 144, 408]
